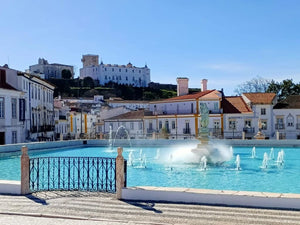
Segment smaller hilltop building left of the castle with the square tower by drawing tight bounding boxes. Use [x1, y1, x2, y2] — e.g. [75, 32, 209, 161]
[29, 58, 74, 79]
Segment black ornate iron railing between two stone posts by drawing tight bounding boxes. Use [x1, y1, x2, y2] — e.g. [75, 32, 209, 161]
[30, 157, 126, 193]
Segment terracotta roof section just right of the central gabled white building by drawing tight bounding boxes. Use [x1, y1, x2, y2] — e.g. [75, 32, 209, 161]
[222, 96, 252, 113]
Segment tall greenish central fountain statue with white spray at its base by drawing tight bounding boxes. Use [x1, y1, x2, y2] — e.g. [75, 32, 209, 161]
[192, 103, 232, 164]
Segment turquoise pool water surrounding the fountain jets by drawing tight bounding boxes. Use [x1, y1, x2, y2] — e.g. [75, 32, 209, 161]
[0, 146, 300, 194]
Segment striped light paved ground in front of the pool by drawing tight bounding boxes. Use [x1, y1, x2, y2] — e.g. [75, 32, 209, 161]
[0, 192, 300, 225]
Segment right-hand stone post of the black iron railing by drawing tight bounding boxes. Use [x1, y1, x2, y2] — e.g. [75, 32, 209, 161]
[116, 147, 125, 199]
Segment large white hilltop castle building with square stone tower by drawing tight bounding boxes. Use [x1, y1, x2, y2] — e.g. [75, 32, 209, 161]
[80, 55, 150, 87]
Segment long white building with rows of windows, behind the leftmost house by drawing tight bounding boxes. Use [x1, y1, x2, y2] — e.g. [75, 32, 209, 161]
[0, 67, 55, 141]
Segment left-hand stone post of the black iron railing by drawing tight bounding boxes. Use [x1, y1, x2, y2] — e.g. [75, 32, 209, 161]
[21, 146, 30, 195]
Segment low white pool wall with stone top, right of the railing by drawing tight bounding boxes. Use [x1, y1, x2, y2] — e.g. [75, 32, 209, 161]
[122, 187, 300, 210]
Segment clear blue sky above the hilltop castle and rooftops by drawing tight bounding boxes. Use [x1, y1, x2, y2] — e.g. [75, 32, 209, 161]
[0, 0, 300, 95]
